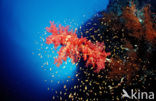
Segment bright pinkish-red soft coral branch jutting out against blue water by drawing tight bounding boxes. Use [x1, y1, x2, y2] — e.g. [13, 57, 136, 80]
[46, 22, 110, 72]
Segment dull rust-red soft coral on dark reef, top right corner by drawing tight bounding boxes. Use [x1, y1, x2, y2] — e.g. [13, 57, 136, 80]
[122, 2, 156, 41]
